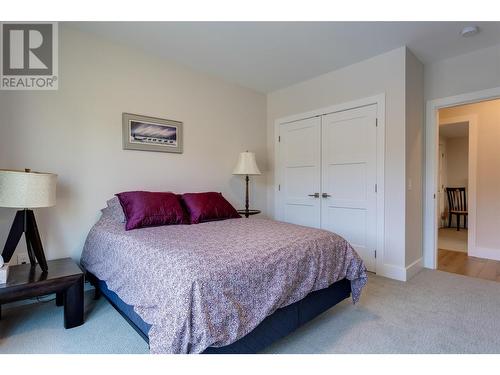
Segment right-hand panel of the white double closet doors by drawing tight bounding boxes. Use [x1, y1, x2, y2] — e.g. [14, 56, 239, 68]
[321, 105, 377, 271]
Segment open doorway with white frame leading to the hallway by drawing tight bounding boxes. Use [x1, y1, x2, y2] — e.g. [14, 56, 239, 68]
[424, 88, 500, 281]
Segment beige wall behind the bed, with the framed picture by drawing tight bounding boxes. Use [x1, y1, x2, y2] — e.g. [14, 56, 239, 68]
[0, 25, 267, 259]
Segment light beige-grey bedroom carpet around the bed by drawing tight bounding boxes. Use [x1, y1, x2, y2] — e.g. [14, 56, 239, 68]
[0, 270, 500, 353]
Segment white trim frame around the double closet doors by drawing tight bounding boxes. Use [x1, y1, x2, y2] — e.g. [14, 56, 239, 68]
[273, 93, 385, 271]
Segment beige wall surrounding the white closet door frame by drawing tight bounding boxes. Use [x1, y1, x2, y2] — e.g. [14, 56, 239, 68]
[267, 47, 412, 274]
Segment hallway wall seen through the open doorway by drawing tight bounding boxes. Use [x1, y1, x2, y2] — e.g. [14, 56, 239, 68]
[439, 100, 500, 253]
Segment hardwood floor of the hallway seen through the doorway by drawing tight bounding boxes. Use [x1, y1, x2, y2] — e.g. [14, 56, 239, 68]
[438, 249, 500, 282]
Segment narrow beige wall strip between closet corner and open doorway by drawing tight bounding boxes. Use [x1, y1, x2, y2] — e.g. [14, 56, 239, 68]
[405, 49, 424, 272]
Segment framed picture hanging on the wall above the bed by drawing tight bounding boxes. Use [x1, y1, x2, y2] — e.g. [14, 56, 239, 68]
[122, 113, 182, 153]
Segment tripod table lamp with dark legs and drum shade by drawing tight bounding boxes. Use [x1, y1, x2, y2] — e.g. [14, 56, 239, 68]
[0, 169, 57, 272]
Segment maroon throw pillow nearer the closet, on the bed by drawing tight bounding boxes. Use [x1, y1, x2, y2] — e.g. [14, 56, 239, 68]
[182, 192, 241, 224]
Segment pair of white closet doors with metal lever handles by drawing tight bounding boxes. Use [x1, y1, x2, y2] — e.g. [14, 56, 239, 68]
[277, 105, 377, 271]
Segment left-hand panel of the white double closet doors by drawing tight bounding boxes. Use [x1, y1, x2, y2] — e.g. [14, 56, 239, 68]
[278, 117, 321, 228]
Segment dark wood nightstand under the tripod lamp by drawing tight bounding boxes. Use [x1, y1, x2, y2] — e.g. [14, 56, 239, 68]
[0, 258, 85, 328]
